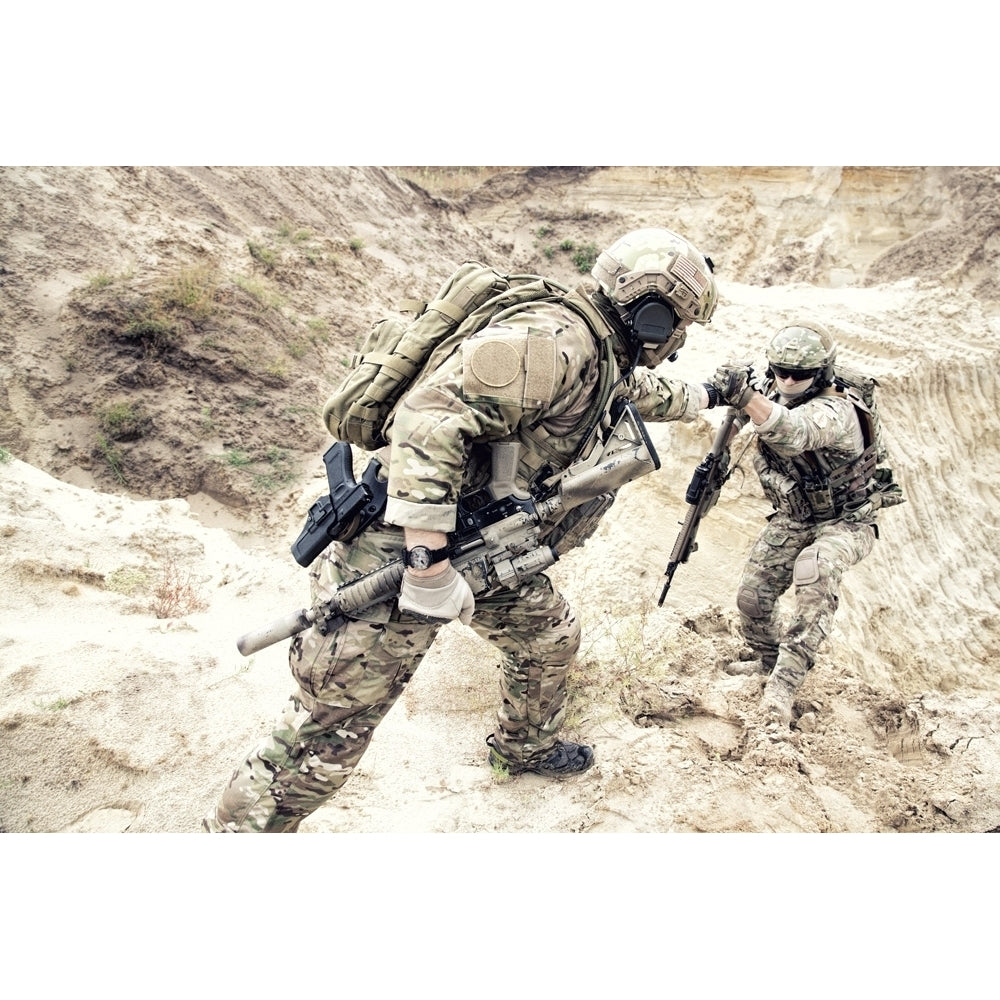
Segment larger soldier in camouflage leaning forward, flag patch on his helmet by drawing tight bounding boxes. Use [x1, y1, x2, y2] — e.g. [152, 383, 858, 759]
[204, 229, 718, 832]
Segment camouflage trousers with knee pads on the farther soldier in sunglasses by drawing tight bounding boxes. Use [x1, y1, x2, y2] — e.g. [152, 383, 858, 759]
[736, 513, 876, 684]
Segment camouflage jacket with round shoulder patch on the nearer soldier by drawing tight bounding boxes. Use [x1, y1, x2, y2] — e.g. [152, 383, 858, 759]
[385, 303, 702, 532]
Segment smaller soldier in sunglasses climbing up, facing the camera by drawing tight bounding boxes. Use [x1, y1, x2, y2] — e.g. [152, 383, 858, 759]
[712, 321, 878, 727]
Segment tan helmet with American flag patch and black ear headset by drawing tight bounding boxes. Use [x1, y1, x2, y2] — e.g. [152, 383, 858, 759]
[591, 229, 719, 368]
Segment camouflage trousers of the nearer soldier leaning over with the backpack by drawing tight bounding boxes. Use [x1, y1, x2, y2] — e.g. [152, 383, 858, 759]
[203, 532, 580, 833]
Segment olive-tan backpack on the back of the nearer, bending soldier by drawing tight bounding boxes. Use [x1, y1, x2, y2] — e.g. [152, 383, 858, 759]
[323, 261, 607, 451]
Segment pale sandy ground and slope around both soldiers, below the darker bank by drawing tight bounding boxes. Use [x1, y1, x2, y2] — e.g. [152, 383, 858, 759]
[0, 166, 1000, 833]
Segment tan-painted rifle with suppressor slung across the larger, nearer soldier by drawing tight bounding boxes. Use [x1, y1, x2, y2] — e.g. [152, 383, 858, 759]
[236, 399, 660, 656]
